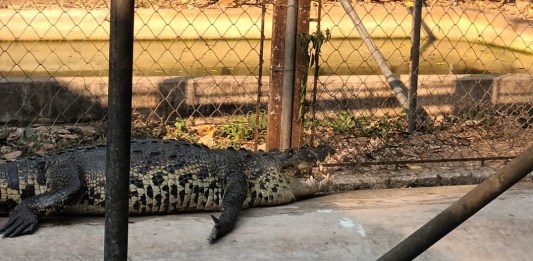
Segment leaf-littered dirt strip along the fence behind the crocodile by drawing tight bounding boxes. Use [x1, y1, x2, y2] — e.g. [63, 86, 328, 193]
[0, 112, 533, 173]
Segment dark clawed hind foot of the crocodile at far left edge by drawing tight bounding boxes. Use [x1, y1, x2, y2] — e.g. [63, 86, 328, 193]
[0, 204, 39, 238]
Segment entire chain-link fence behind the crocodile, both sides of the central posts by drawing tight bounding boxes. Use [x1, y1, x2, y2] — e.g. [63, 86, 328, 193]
[0, 0, 533, 167]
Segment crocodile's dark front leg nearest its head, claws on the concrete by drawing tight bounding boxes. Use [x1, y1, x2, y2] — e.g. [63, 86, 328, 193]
[208, 173, 248, 243]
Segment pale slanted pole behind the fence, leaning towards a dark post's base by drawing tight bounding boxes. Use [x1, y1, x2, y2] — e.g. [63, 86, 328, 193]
[340, 0, 431, 127]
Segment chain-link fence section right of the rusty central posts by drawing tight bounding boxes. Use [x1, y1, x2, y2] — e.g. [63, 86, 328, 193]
[315, 1, 533, 163]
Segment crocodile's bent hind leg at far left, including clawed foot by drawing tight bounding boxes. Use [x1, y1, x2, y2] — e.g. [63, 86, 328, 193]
[0, 162, 83, 238]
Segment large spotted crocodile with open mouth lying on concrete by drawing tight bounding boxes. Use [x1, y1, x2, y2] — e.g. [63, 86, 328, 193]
[0, 140, 334, 243]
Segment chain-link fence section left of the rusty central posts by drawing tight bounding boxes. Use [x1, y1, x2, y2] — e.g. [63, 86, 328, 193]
[0, 0, 270, 154]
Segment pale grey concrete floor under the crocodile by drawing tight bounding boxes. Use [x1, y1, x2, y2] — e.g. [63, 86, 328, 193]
[0, 184, 533, 261]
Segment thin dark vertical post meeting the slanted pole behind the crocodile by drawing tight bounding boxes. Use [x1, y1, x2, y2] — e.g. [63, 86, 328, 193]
[407, 0, 422, 133]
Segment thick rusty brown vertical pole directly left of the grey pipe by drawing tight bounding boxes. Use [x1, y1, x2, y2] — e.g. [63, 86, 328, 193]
[266, 0, 287, 150]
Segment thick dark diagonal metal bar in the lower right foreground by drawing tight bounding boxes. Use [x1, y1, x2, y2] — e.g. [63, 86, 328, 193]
[378, 146, 533, 261]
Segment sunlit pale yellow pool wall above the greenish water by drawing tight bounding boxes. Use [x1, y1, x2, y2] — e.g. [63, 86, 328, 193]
[0, 3, 533, 53]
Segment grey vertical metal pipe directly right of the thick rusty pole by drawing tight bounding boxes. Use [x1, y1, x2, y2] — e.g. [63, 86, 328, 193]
[280, 0, 298, 149]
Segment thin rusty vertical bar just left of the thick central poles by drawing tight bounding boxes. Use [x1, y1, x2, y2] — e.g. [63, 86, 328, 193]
[254, 0, 266, 151]
